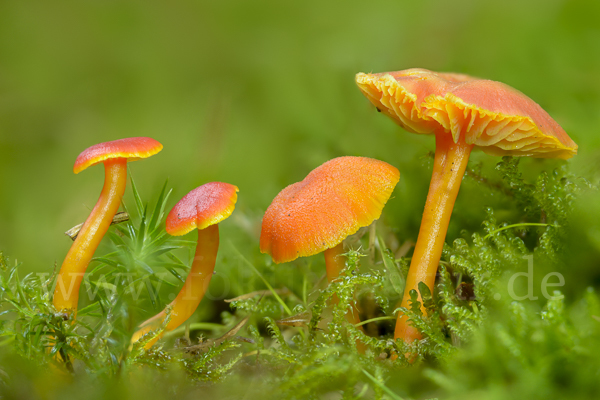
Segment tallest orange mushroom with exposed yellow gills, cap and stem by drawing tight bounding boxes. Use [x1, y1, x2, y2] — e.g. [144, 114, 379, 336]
[356, 68, 577, 342]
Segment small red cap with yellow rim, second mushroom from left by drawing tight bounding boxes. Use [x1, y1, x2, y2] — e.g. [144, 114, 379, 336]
[166, 182, 239, 236]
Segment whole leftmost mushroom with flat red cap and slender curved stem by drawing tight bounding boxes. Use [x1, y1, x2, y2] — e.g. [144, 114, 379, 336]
[53, 137, 163, 316]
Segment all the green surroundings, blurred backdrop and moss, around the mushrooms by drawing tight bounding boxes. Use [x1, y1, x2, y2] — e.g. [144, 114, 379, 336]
[0, 0, 600, 400]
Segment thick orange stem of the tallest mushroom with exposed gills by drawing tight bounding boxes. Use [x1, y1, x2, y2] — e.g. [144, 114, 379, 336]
[394, 132, 473, 342]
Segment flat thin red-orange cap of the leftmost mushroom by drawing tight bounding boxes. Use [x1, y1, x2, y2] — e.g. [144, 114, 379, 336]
[73, 137, 162, 174]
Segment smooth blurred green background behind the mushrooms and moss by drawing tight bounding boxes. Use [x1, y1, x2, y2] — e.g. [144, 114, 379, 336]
[0, 0, 600, 271]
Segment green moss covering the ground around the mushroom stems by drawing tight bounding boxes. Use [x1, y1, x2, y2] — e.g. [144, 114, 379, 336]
[0, 157, 600, 399]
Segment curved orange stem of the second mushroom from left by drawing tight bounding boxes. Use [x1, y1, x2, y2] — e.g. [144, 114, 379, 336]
[131, 224, 219, 349]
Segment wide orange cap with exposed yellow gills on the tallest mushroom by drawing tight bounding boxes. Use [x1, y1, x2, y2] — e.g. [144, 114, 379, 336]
[356, 68, 577, 159]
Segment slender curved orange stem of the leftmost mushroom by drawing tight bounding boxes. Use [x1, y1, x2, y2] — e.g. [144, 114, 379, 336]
[53, 158, 127, 317]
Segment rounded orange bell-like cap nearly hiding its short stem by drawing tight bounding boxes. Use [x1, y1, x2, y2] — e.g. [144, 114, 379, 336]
[260, 157, 400, 263]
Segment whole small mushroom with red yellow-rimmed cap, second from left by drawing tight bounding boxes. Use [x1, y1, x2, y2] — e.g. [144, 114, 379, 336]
[131, 182, 238, 348]
